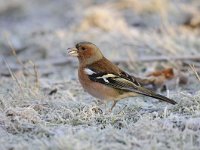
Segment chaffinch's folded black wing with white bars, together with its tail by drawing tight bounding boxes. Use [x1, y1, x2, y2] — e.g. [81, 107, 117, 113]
[84, 68, 176, 104]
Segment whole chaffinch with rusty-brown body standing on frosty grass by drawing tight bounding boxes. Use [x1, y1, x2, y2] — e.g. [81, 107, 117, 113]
[68, 42, 176, 111]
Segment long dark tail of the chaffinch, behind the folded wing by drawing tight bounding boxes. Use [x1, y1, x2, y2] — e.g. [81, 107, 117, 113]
[138, 87, 177, 105]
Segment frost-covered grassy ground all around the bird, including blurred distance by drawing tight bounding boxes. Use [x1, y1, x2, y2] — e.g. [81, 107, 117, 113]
[0, 0, 200, 150]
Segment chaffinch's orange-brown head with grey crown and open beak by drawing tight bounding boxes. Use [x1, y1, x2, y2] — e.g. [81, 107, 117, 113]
[68, 42, 103, 65]
